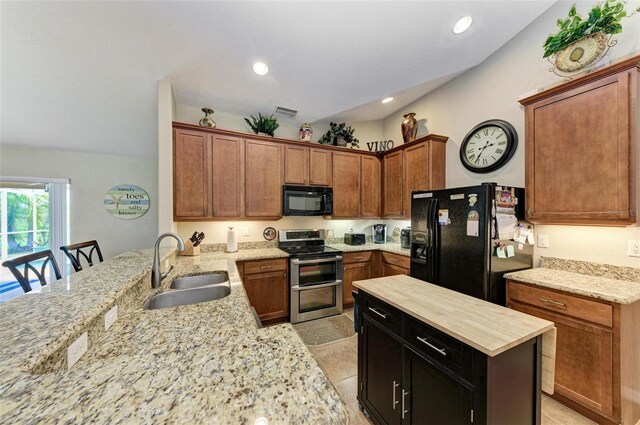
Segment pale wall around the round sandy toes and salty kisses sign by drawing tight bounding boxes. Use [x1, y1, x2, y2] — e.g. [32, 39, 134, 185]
[0, 144, 158, 258]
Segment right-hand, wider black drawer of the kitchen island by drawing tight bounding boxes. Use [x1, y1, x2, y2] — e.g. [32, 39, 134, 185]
[403, 315, 472, 381]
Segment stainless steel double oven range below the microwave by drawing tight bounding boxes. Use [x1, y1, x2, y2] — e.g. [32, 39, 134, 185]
[278, 229, 342, 323]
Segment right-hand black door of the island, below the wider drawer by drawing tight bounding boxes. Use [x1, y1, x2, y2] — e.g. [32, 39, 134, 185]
[400, 346, 482, 425]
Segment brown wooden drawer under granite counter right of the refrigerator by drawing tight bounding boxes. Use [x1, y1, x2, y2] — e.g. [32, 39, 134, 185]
[508, 280, 613, 327]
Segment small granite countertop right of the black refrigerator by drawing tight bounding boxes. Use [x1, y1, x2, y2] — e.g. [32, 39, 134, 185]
[504, 267, 640, 304]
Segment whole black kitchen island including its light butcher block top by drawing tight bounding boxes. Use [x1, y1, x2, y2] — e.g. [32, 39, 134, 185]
[354, 276, 554, 424]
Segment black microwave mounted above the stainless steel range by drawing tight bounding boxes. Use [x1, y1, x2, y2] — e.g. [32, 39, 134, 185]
[282, 185, 333, 215]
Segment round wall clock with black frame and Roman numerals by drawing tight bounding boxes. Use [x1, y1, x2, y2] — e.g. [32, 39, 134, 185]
[460, 120, 518, 173]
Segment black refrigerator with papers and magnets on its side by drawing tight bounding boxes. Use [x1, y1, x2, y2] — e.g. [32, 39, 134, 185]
[411, 183, 533, 305]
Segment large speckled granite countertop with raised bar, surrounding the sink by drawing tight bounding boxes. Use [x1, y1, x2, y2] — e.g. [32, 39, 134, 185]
[0, 248, 348, 424]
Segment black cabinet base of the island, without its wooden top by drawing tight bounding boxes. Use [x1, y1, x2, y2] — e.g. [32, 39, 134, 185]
[358, 290, 541, 425]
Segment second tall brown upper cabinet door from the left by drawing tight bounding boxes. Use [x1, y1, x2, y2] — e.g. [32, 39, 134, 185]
[212, 135, 244, 217]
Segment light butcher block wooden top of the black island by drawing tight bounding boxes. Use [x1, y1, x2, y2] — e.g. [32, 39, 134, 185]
[353, 275, 554, 357]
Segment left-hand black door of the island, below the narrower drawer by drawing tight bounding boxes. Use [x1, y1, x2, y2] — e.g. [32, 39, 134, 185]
[358, 315, 402, 424]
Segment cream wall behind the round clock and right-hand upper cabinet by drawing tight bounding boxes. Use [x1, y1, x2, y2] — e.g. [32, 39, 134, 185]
[384, 1, 640, 267]
